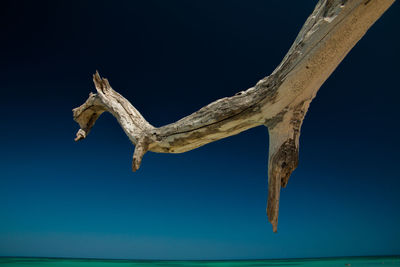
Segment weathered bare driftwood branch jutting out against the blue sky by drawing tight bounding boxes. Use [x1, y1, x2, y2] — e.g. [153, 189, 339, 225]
[73, 0, 394, 232]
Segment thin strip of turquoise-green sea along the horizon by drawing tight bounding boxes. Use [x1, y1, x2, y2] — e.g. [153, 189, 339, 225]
[0, 256, 400, 267]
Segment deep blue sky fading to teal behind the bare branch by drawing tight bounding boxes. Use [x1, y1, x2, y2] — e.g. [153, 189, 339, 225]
[0, 0, 400, 259]
